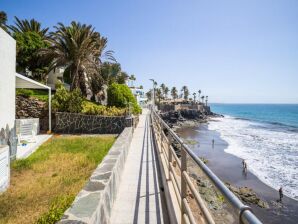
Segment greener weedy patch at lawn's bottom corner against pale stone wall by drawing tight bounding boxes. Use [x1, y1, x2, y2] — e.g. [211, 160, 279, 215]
[37, 195, 75, 224]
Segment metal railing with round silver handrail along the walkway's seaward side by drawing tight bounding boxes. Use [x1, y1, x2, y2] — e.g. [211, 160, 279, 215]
[151, 110, 261, 224]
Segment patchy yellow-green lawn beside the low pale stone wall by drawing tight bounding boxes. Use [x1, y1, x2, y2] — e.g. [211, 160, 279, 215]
[0, 136, 115, 224]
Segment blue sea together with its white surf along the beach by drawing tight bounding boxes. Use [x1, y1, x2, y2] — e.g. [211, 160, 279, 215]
[208, 104, 298, 200]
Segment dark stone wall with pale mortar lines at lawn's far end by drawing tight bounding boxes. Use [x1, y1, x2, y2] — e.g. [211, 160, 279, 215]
[55, 112, 134, 134]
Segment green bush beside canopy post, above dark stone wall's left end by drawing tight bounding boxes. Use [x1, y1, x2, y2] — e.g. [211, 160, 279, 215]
[52, 86, 84, 113]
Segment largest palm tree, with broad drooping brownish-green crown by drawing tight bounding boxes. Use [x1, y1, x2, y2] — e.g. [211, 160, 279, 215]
[40, 21, 115, 92]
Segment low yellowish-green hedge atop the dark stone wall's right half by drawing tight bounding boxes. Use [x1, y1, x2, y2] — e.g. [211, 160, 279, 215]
[82, 101, 126, 116]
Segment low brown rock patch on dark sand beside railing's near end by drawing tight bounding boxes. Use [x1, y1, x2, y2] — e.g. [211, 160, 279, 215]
[226, 183, 269, 208]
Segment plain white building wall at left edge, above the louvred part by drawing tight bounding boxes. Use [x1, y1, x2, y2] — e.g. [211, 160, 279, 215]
[0, 28, 16, 145]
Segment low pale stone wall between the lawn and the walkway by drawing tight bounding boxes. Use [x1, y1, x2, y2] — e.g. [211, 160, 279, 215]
[58, 127, 133, 224]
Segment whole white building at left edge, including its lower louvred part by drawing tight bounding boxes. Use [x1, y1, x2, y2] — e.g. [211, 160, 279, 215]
[0, 28, 16, 192]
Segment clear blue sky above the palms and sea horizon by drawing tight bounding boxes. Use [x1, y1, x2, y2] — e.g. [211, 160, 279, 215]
[0, 0, 298, 103]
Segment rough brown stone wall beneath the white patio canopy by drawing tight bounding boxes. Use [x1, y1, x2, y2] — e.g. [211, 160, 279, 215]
[16, 96, 50, 131]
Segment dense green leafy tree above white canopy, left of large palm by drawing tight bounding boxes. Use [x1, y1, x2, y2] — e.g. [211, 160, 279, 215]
[14, 31, 48, 78]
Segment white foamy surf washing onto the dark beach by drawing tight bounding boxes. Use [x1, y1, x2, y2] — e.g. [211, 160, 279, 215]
[208, 116, 298, 200]
